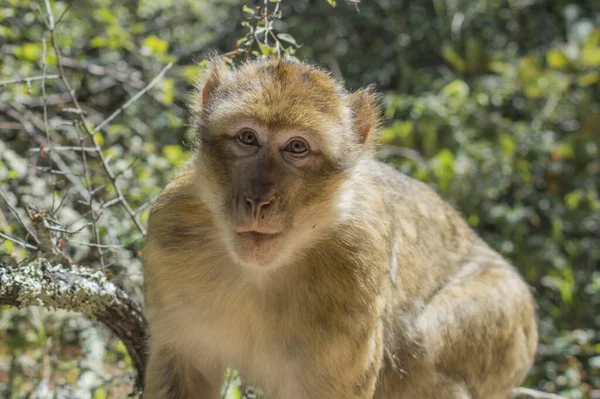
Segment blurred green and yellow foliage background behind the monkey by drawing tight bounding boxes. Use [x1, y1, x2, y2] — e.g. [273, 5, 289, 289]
[0, 0, 600, 399]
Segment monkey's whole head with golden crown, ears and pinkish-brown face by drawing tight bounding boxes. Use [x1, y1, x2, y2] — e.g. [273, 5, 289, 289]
[190, 60, 379, 268]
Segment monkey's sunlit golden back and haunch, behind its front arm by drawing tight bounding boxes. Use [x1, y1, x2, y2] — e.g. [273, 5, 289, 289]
[362, 160, 537, 399]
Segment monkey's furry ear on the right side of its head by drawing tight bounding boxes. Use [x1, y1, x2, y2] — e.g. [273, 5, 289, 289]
[350, 86, 380, 143]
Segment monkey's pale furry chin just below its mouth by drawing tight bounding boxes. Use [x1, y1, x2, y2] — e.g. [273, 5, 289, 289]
[233, 231, 283, 268]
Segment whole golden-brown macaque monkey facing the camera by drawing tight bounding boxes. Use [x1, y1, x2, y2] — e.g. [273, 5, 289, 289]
[143, 60, 537, 399]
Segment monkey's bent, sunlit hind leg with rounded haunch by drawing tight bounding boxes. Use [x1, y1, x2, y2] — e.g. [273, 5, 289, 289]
[377, 260, 537, 399]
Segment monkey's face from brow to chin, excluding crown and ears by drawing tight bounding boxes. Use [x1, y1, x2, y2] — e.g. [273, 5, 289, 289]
[199, 120, 352, 267]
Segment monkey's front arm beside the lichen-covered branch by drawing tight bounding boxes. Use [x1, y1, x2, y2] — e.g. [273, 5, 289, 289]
[142, 168, 224, 399]
